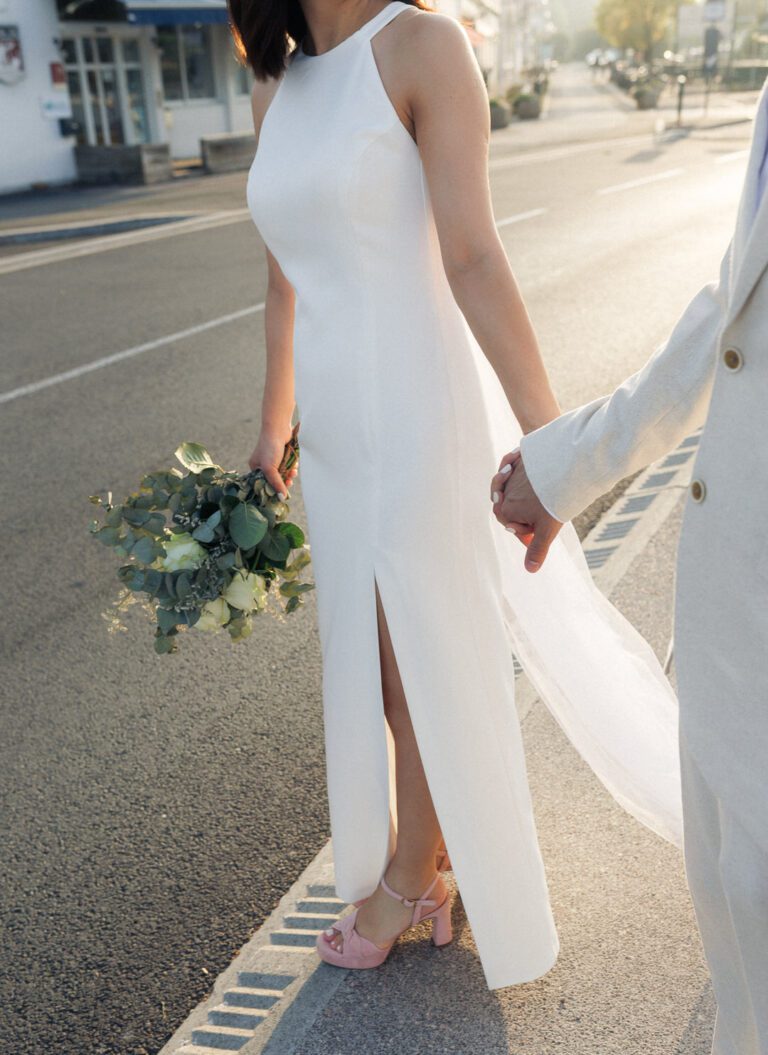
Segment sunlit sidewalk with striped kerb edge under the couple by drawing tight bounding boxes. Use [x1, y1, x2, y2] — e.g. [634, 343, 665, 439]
[160, 447, 714, 1055]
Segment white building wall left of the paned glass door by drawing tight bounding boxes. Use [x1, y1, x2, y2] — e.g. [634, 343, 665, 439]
[0, 0, 75, 193]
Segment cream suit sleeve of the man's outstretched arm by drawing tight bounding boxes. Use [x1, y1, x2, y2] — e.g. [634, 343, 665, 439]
[520, 241, 730, 522]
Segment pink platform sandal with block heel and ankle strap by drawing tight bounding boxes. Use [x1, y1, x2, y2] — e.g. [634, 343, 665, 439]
[318, 872, 454, 970]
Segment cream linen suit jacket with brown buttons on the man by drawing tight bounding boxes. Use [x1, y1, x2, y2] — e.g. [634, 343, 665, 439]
[521, 89, 768, 846]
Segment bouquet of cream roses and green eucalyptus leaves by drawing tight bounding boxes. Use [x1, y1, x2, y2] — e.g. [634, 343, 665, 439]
[91, 426, 313, 654]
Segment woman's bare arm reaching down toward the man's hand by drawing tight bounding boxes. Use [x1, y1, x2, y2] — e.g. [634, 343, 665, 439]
[376, 13, 559, 433]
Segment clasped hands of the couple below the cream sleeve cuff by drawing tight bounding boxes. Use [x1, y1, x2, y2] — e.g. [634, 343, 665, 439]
[491, 450, 562, 572]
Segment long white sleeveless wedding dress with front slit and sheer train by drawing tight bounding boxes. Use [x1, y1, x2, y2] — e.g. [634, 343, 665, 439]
[248, 2, 681, 989]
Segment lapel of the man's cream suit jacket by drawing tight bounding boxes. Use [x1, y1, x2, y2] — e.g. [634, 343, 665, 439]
[729, 85, 768, 319]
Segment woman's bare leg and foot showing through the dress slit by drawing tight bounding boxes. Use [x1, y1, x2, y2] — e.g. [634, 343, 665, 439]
[331, 590, 442, 948]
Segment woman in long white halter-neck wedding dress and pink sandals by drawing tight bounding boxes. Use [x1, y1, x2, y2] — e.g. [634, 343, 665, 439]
[230, 0, 680, 987]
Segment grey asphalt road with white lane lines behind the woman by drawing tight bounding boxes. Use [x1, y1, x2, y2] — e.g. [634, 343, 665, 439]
[0, 65, 750, 1055]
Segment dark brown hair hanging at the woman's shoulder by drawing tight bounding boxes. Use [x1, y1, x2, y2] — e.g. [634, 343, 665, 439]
[227, 0, 430, 80]
